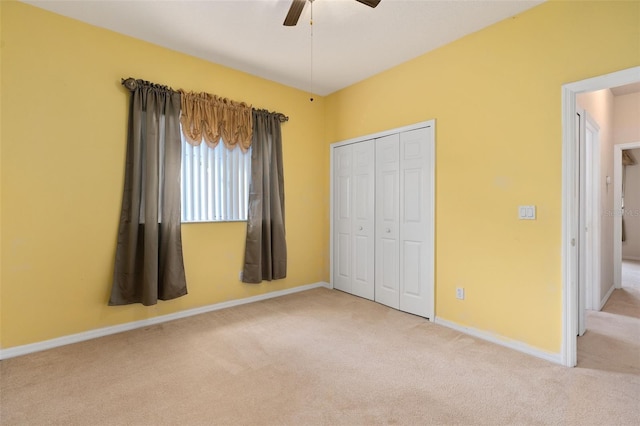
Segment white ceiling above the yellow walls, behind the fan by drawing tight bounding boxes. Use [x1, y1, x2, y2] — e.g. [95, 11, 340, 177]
[23, 0, 543, 95]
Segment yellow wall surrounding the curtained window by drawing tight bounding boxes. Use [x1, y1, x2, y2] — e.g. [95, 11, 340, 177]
[0, 1, 328, 349]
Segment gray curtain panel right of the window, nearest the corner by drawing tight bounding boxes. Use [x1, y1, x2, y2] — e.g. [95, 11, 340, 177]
[242, 110, 287, 283]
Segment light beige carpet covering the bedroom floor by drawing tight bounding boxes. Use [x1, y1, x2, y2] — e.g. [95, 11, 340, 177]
[0, 289, 640, 425]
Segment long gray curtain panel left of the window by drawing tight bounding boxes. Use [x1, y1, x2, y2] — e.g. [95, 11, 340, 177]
[109, 79, 187, 306]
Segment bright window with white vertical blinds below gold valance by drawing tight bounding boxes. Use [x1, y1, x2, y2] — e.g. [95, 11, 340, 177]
[181, 132, 251, 223]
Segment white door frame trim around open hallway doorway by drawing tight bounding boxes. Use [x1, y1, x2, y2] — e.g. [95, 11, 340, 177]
[560, 66, 640, 367]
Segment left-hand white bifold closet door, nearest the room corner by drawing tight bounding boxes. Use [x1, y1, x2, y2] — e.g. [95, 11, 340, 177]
[333, 140, 375, 300]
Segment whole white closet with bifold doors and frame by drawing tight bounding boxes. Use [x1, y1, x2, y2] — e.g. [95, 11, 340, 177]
[331, 121, 435, 319]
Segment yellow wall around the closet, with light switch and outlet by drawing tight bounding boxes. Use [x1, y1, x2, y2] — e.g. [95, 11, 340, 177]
[325, 1, 640, 353]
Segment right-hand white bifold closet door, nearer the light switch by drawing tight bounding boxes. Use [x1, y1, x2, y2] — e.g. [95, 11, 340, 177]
[375, 128, 433, 316]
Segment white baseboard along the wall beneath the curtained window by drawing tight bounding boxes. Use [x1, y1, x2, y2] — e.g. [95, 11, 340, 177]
[0, 281, 331, 360]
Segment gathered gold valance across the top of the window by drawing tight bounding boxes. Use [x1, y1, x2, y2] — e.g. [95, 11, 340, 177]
[180, 90, 253, 152]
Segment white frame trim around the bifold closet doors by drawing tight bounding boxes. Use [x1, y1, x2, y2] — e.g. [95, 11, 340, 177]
[329, 119, 437, 322]
